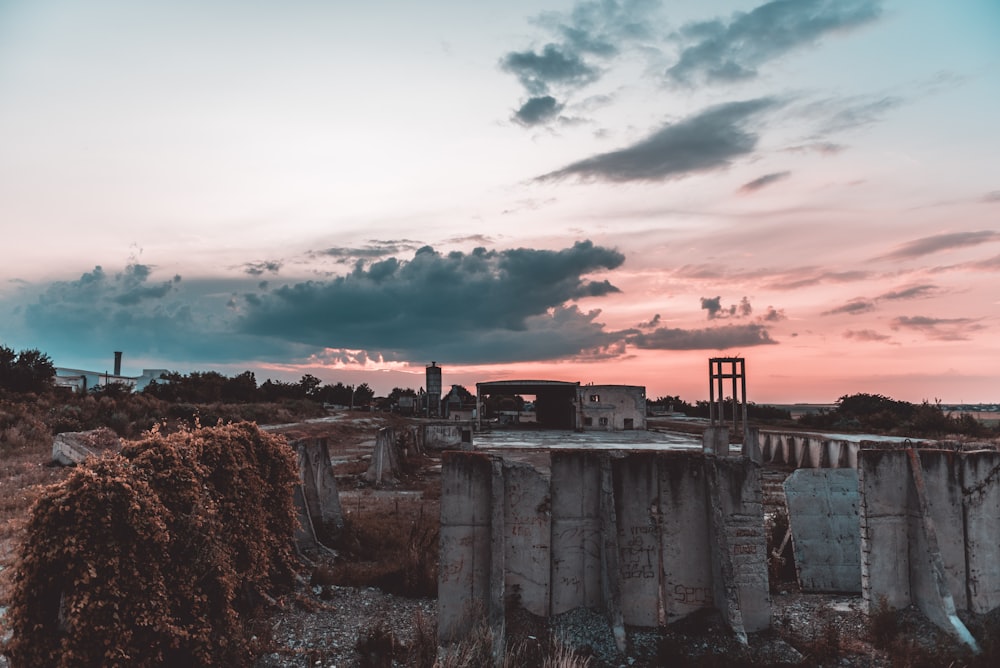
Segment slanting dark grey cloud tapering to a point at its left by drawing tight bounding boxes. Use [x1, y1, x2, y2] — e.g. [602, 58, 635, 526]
[539, 98, 777, 182]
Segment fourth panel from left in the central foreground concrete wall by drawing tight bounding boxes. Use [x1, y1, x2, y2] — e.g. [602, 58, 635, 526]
[612, 452, 662, 626]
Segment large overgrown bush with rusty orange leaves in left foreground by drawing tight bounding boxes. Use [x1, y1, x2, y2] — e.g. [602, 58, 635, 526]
[4, 422, 298, 667]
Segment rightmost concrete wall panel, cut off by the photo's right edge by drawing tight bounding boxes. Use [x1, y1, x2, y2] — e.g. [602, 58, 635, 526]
[961, 451, 1000, 613]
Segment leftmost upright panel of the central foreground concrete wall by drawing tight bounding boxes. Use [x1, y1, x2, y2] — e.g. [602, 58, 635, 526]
[438, 453, 492, 642]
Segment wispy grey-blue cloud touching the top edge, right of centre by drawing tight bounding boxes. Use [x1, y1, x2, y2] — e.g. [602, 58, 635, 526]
[667, 0, 881, 84]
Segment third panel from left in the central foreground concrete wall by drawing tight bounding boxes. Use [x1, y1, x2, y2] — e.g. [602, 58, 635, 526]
[551, 450, 603, 615]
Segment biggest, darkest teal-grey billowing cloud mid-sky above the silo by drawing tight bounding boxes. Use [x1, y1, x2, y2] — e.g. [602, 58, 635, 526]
[239, 241, 624, 363]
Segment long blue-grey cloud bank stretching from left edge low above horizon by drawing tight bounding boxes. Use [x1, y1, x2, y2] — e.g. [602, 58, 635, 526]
[0, 241, 800, 364]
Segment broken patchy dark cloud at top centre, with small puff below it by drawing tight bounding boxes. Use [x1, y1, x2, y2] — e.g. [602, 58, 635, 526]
[508, 0, 660, 127]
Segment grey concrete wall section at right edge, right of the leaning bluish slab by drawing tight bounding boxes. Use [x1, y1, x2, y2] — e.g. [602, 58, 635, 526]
[859, 449, 1000, 640]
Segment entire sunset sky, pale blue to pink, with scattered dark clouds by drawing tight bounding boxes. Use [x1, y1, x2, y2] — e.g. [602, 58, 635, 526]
[0, 0, 1000, 403]
